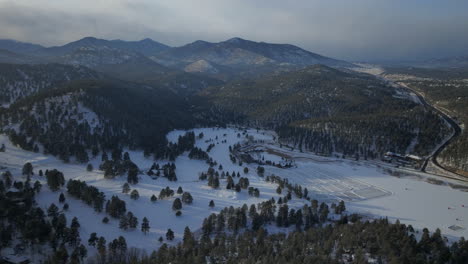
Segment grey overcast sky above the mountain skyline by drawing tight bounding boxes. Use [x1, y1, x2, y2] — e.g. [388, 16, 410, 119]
[0, 0, 468, 60]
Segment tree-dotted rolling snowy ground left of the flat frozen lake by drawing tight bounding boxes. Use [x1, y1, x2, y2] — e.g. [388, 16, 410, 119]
[0, 128, 301, 255]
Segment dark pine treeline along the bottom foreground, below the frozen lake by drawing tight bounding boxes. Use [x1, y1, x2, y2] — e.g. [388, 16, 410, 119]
[86, 201, 468, 264]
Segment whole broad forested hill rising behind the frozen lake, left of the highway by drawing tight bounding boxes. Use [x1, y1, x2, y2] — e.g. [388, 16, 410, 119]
[203, 65, 449, 158]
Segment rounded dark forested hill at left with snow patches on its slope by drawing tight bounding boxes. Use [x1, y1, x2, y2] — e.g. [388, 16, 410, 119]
[0, 77, 218, 162]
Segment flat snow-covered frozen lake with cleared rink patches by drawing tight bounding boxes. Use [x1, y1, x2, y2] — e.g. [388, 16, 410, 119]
[241, 137, 468, 240]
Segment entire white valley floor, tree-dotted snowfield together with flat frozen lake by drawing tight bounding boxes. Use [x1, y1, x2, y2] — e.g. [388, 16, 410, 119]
[0, 128, 468, 255]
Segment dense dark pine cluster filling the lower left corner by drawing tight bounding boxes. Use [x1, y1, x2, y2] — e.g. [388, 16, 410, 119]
[0, 172, 87, 263]
